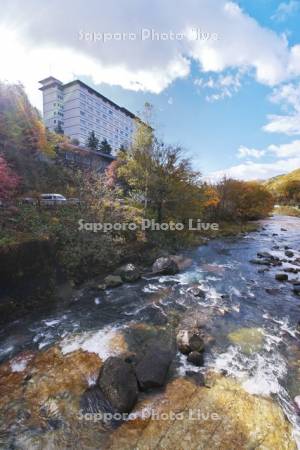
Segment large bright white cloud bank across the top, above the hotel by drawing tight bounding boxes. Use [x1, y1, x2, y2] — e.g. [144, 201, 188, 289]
[0, 0, 300, 108]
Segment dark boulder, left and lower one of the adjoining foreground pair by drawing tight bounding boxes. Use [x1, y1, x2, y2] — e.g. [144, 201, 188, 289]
[97, 356, 138, 412]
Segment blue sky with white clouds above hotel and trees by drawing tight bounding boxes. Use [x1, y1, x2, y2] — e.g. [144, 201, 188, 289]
[0, 0, 300, 180]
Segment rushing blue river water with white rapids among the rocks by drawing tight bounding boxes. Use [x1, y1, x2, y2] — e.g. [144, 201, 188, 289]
[0, 216, 300, 448]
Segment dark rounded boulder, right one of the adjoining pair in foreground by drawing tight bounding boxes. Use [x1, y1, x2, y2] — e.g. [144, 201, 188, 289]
[135, 345, 173, 391]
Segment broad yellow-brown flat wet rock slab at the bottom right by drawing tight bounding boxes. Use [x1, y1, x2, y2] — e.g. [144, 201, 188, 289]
[107, 377, 297, 450]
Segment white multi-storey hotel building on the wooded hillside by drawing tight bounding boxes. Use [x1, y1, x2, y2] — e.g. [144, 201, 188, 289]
[40, 77, 137, 151]
